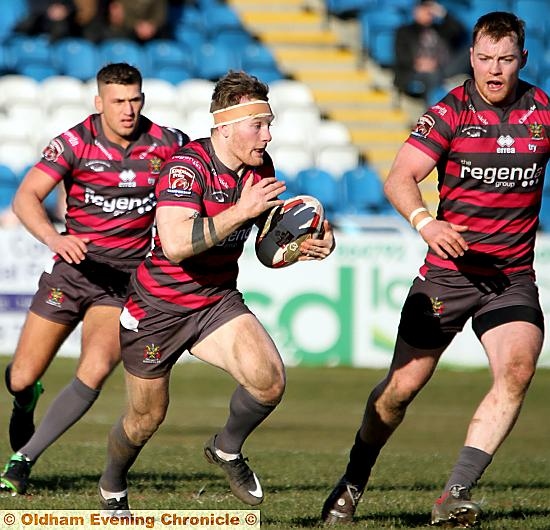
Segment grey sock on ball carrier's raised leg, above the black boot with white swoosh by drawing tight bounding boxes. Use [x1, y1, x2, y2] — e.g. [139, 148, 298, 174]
[216, 385, 277, 454]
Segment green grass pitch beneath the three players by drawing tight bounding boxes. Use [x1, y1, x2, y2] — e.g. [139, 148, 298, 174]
[0, 357, 550, 530]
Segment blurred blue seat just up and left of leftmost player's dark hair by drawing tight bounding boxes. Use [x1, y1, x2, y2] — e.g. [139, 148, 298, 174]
[52, 37, 102, 81]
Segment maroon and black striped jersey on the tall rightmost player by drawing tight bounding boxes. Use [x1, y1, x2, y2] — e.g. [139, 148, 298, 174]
[407, 79, 550, 275]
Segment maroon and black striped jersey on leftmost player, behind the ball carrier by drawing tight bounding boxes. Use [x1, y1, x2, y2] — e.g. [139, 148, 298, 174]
[35, 114, 189, 270]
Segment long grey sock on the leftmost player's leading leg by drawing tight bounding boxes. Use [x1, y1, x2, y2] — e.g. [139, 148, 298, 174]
[19, 377, 99, 462]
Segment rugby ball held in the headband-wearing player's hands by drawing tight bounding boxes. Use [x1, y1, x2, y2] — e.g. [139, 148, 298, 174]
[256, 195, 325, 269]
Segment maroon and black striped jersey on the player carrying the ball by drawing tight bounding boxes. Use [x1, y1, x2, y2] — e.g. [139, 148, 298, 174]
[133, 138, 275, 314]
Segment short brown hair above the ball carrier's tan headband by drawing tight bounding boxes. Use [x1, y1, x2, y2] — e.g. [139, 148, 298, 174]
[210, 70, 269, 112]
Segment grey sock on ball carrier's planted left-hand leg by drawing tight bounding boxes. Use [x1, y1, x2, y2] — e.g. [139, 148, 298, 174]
[99, 418, 145, 492]
